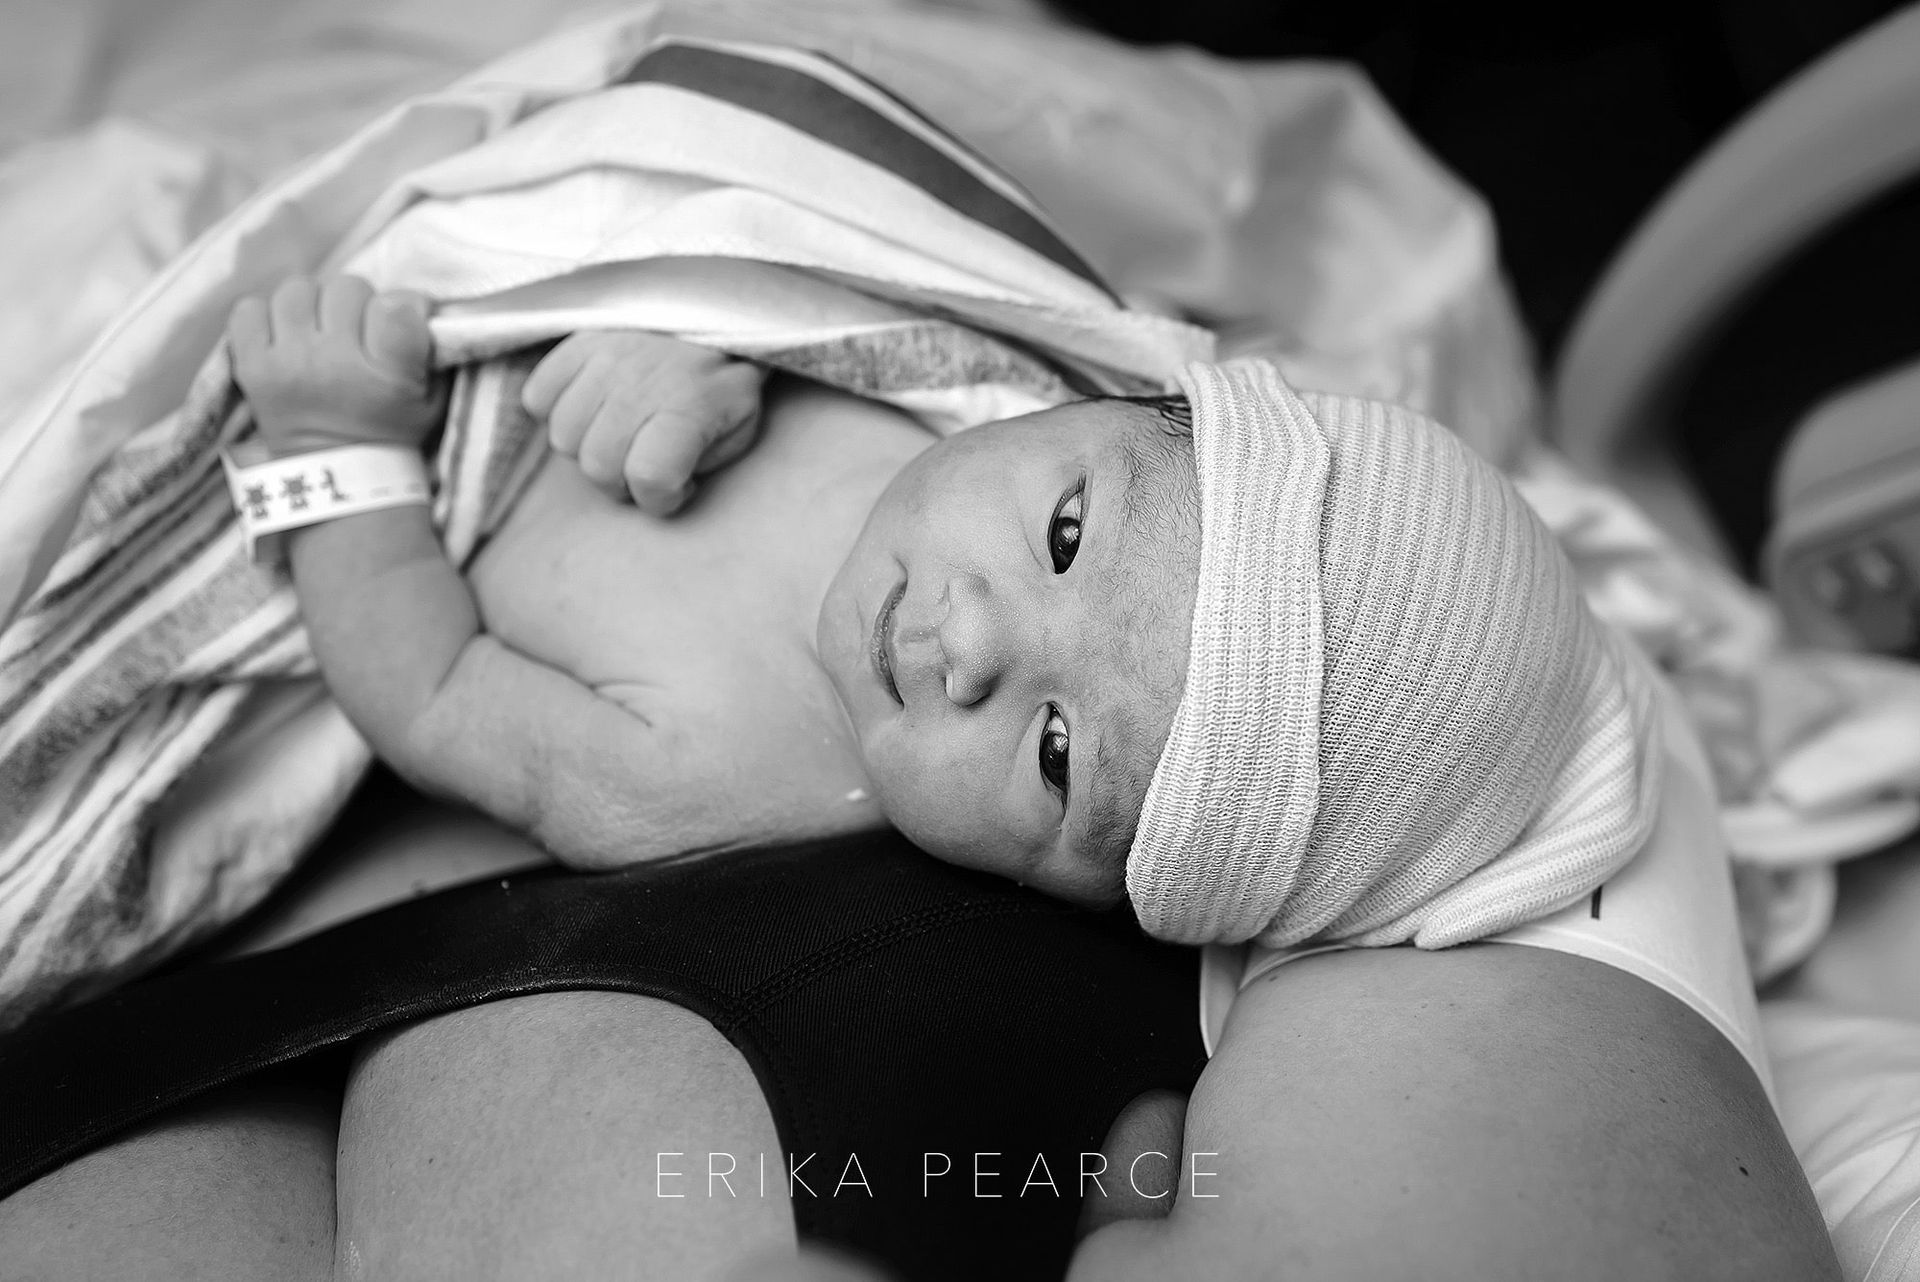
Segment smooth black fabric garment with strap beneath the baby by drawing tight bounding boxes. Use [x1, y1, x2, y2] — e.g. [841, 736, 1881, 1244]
[0, 835, 1204, 1278]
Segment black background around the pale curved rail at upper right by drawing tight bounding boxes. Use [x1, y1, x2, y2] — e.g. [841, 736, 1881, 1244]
[1054, 0, 1920, 568]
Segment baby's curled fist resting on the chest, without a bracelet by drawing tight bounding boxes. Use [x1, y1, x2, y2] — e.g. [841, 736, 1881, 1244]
[520, 330, 766, 516]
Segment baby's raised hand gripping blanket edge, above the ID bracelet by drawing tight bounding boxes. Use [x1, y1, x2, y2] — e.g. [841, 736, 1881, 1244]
[227, 276, 447, 455]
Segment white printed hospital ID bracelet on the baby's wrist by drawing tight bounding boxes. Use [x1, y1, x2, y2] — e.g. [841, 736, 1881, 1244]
[221, 445, 432, 562]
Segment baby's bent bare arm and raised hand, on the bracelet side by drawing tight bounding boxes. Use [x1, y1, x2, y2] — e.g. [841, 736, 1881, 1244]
[228, 278, 748, 867]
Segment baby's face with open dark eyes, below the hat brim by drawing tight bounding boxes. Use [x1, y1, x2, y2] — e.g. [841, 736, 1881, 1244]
[816, 401, 1200, 906]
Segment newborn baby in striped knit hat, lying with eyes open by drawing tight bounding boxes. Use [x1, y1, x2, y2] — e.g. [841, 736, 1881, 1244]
[228, 278, 1657, 946]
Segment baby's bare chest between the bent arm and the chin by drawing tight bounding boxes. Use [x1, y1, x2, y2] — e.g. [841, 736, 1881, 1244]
[468, 380, 931, 835]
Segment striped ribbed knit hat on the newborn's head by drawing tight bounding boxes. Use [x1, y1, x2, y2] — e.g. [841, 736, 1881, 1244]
[1127, 361, 1661, 948]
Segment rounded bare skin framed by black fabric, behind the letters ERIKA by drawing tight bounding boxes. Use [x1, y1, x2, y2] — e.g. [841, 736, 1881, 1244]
[338, 992, 795, 1280]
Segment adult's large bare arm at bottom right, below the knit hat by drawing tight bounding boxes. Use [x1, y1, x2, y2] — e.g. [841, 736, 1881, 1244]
[1069, 944, 1839, 1282]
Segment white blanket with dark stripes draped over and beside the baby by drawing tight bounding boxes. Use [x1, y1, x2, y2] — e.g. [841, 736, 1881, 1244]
[0, 29, 1212, 1019]
